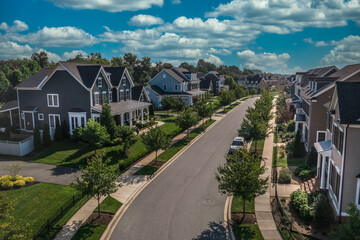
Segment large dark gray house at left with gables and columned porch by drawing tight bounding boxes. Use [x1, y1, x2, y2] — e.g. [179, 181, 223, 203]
[0, 62, 151, 138]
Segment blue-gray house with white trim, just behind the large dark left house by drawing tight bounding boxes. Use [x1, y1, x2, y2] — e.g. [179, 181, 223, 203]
[146, 67, 205, 108]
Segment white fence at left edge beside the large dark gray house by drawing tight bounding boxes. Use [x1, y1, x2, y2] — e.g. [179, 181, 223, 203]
[0, 136, 34, 157]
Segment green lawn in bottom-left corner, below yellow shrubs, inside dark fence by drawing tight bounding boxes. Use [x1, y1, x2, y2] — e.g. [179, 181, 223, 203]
[0, 183, 76, 235]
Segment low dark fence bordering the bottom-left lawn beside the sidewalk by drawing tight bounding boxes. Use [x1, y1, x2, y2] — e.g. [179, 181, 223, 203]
[33, 192, 84, 240]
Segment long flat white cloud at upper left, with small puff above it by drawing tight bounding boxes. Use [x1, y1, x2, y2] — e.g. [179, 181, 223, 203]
[0, 22, 99, 47]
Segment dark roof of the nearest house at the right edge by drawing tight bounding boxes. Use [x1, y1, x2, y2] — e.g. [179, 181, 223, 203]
[336, 82, 360, 124]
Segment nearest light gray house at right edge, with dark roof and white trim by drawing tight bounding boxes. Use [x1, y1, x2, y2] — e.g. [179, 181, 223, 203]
[315, 82, 360, 217]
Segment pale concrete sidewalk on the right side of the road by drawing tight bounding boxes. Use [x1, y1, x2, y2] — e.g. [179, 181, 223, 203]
[255, 100, 282, 240]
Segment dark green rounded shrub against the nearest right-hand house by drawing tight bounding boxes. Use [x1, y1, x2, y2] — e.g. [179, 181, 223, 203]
[312, 194, 332, 228]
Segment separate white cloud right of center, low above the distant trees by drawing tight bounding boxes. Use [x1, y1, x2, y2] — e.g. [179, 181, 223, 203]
[236, 50, 290, 72]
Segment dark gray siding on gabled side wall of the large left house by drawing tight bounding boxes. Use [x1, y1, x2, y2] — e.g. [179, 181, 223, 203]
[18, 70, 90, 129]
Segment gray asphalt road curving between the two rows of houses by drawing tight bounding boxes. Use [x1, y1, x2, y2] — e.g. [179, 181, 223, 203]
[111, 99, 255, 240]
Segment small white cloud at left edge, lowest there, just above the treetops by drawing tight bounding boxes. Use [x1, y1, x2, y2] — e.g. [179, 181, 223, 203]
[0, 41, 34, 59]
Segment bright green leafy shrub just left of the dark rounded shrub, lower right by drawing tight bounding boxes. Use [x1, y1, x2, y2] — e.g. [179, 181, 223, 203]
[290, 189, 311, 221]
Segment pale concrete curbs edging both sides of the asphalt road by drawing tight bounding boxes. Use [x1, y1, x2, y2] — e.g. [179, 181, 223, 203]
[100, 99, 255, 240]
